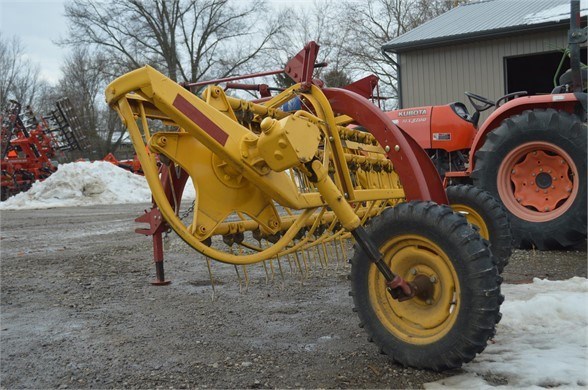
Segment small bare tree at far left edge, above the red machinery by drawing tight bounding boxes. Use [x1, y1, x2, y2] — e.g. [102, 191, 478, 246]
[0, 32, 39, 108]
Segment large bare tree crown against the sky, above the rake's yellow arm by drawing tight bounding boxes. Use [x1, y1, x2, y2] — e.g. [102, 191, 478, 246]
[63, 0, 288, 81]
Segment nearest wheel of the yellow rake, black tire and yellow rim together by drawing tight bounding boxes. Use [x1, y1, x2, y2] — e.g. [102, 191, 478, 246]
[351, 202, 504, 371]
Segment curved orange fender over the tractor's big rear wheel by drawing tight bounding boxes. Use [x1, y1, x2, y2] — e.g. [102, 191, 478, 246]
[468, 93, 583, 173]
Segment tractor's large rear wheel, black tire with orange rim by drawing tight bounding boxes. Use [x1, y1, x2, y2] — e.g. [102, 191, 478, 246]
[472, 109, 587, 250]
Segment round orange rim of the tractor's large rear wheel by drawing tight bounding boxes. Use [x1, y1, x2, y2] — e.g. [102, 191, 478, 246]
[497, 141, 579, 222]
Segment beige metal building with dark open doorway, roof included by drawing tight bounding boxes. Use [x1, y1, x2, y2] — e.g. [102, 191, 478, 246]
[382, 0, 588, 108]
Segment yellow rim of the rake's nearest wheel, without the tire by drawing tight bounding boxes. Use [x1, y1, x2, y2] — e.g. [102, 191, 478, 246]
[368, 235, 460, 345]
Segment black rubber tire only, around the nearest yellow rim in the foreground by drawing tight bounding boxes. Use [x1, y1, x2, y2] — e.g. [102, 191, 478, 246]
[350, 202, 504, 371]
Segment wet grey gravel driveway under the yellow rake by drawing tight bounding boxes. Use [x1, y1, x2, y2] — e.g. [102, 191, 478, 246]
[0, 205, 586, 389]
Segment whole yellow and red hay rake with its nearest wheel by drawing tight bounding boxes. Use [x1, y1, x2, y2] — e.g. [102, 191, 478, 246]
[106, 42, 500, 370]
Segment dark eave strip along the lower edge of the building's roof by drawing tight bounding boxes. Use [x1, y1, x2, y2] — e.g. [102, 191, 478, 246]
[382, 19, 569, 53]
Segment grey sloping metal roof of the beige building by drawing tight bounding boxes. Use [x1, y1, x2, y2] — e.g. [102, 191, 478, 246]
[382, 0, 588, 52]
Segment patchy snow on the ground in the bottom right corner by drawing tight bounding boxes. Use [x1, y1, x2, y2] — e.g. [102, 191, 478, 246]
[425, 277, 588, 389]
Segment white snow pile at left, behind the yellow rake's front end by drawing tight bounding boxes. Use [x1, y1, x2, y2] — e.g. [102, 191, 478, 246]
[0, 161, 195, 210]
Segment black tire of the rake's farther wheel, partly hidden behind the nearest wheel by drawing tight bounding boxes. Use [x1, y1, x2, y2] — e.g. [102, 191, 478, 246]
[446, 184, 513, 273]
